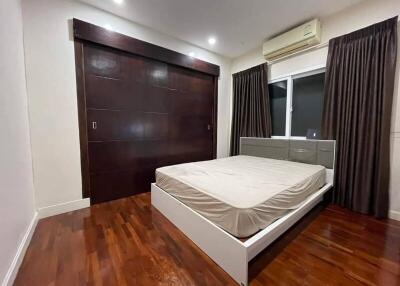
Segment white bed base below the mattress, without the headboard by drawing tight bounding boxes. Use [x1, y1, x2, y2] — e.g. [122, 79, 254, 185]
[151, 183, 332, 286]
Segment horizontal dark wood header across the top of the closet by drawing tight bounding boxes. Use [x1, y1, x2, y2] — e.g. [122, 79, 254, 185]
[73, 19, 219, 76]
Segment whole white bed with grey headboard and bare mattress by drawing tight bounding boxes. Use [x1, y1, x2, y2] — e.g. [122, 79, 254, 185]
[151, 138, 335, 285]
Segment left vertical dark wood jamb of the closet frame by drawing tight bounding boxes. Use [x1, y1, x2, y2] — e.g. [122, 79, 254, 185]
[74, 40, 90, 198]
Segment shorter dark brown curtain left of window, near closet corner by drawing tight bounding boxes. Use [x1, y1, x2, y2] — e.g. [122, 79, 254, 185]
[230, 64, 272, 156]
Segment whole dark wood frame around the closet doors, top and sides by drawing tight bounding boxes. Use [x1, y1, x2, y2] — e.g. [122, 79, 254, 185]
[72, 18, 220, 198]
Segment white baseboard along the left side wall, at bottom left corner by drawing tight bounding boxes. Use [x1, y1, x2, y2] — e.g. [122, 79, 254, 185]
[1, 212, 39, 286]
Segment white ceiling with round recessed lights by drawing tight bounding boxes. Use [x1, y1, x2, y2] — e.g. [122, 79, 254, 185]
[80, 0, 362, 58]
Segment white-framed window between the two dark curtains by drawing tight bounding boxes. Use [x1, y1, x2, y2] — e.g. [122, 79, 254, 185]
[268, 69, 325, 138]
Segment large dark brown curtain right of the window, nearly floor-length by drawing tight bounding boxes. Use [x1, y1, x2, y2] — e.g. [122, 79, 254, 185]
[322, 17, 397, 218]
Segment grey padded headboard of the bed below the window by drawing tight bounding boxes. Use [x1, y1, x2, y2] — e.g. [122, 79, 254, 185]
[240, 137, 335, 169]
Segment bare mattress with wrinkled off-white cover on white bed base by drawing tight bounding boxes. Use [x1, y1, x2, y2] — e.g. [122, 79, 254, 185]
[156, 156, 325, 238]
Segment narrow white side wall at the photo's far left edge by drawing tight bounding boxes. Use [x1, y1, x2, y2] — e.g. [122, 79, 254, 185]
[0, 0, 35, 283]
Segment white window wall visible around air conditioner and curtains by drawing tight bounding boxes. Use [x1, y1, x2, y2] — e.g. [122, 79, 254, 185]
[231, 0, 400, 219]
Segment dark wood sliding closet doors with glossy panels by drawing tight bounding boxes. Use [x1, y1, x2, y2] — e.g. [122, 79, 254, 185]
[83, 44, 214, 203]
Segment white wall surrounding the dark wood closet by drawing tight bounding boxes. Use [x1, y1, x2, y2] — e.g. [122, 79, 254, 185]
[23, 0, 231, 208]
